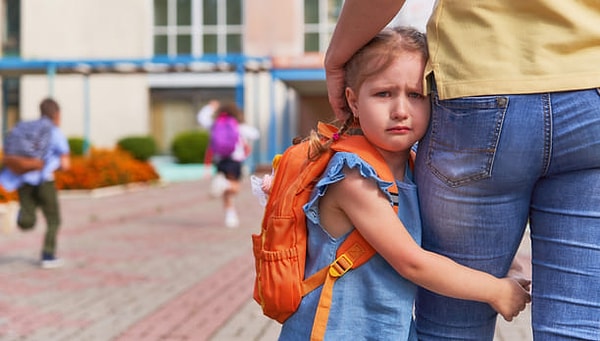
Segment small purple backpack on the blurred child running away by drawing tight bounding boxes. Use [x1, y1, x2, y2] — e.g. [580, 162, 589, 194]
[209, 113, 240, 157]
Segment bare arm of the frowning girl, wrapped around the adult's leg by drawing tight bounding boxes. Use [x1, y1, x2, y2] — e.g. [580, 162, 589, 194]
[320, 170, 530, 321]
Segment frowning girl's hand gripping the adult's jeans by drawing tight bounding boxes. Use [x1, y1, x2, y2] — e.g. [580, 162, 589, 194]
[490, 278, 531, 321]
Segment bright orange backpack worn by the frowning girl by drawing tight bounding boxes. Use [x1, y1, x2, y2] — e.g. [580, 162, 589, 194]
[252, 123, 406, 339]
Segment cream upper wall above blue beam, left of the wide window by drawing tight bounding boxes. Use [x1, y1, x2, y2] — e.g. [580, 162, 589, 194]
[21, 0, 152, 58]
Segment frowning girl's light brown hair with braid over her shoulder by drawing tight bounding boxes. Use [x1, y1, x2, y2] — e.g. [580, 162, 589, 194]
[308, 26, 429, 160]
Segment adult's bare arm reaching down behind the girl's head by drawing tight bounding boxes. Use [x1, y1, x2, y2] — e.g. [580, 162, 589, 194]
[325, 0, 404, 121]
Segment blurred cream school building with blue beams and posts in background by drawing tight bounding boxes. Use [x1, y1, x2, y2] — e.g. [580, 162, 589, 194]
[0, 0, 433, 168]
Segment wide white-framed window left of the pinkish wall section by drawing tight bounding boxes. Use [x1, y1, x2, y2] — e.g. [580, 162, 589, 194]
[154, 0, 244, 56]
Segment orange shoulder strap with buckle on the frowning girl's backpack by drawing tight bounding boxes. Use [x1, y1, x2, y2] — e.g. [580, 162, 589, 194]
[302, 123, 398, 340]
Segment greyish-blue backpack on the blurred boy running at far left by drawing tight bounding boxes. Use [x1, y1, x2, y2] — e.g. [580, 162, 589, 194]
[4, 118, 54, 174]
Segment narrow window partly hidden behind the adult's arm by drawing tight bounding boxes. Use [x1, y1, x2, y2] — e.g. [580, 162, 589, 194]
[304, 0, 343, 52]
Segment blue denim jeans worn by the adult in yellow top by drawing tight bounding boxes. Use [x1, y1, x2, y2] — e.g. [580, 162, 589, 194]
[415, 89, 600, 341]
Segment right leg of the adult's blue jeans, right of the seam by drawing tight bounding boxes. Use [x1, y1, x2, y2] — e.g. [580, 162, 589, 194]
[531, 90, 600, 341]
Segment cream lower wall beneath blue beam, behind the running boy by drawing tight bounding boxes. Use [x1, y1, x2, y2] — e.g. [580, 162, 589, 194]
[21, 75, 150, 147]
